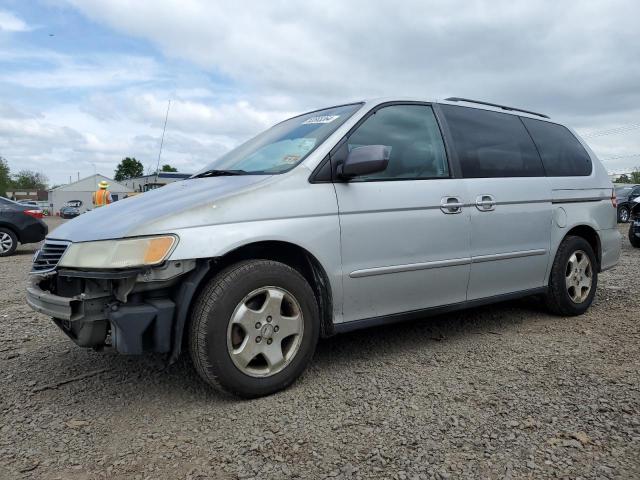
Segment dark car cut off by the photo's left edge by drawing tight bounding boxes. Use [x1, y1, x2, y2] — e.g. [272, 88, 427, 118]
[0, 197, 49, 257]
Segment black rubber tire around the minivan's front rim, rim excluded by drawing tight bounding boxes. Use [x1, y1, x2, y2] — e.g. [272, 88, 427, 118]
[188, 260, 320, 398]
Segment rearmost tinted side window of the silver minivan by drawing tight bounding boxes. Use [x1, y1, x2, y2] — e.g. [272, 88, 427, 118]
[522, 118, 591, 177]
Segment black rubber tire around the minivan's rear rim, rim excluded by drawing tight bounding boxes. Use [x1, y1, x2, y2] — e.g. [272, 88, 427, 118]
[545, 236, 599, 317]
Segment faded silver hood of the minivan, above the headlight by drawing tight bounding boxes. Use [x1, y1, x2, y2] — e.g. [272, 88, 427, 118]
[48, 175, 271, 242]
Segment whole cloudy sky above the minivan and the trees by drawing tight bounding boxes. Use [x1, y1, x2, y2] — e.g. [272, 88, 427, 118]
[0, 0, 640, 183]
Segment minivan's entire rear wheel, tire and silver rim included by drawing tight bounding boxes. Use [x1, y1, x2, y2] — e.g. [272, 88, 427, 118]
[545, 236, 598, 316]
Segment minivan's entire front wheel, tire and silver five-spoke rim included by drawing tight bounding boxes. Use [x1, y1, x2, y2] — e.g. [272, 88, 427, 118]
[189, 260, 320, 398]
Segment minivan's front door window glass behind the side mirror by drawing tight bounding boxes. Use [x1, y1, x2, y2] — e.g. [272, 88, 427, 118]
[341, 105, 449, 181]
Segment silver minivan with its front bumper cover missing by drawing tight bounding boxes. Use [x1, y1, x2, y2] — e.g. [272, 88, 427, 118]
[27, 97, 621, 397]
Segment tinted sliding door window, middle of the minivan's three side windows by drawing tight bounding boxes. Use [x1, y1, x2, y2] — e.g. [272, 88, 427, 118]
[441, 105, 544, 178]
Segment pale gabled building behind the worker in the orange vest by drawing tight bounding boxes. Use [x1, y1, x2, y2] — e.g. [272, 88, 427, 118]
[49, 173, 133, 215]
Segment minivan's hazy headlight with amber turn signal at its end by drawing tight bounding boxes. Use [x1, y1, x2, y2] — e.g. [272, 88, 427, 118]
[59, 235, 178, 268]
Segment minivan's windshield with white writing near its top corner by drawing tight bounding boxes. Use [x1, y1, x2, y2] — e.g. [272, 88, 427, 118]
[195, 103, 362, 176]
